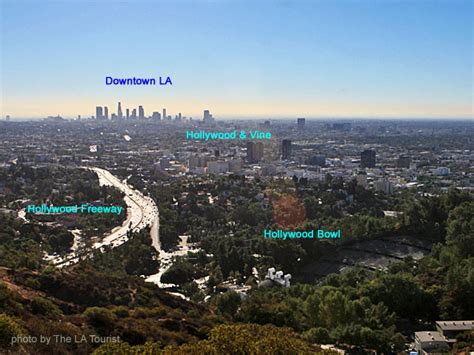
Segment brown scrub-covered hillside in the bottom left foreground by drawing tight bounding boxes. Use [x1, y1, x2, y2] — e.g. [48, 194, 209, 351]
[0, 268, 217, 354]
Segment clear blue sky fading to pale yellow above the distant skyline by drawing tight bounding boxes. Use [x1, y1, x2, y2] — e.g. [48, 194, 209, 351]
[0, 0, 473, 118]
